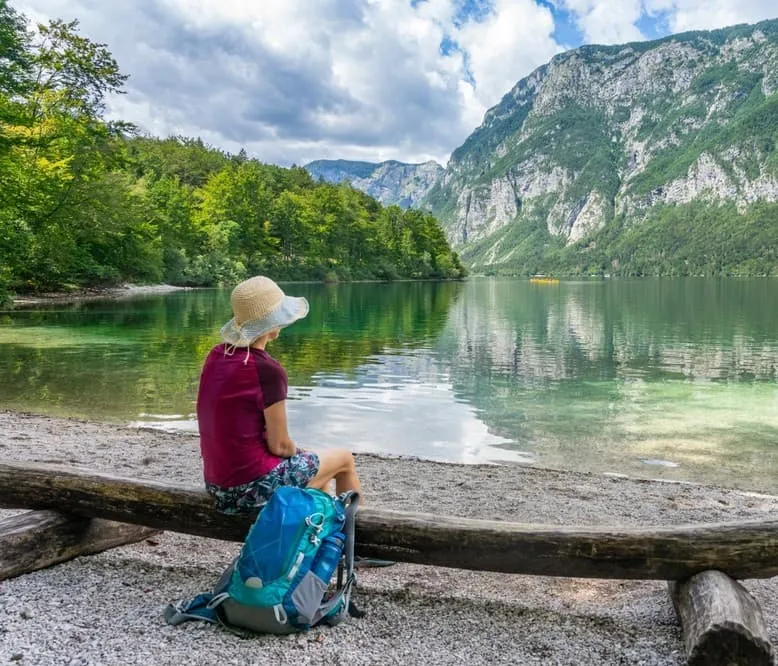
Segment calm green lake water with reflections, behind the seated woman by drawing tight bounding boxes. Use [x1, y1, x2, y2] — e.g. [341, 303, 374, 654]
[0, 279, 778, 491]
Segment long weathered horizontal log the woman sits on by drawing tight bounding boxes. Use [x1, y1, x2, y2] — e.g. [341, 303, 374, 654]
[0, 463, 778, 580]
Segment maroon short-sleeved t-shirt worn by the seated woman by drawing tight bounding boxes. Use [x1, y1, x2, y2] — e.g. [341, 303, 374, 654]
[197, 344, 288, 488]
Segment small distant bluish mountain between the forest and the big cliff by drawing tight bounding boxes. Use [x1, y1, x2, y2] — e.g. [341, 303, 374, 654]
[305, 160, 443, 208]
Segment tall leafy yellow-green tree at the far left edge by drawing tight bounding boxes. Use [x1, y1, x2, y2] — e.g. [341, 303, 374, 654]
[0, 16, 133, 287]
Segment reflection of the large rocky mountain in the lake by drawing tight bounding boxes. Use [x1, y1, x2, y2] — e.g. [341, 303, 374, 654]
[452, 280, 778, 383]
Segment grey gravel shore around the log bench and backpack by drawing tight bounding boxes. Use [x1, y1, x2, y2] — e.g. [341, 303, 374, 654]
[0, 412, 778, 666]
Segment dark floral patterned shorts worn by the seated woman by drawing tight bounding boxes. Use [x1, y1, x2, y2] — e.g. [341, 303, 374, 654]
[205, 450, 319, 514]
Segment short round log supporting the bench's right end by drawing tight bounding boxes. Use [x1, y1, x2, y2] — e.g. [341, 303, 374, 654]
[669, 571, 774, 666]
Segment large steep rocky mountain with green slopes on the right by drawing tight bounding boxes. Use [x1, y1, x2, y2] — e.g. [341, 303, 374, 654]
[421, 20, 778, 275]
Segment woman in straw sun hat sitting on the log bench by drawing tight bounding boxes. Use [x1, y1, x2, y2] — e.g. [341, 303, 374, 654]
[197, 276, 360, 514]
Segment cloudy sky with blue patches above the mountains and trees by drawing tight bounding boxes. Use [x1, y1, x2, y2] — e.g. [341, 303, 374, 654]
[10, 0, 778, 165]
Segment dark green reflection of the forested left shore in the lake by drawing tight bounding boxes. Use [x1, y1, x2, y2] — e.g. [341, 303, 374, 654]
[0, 283, 462, 420]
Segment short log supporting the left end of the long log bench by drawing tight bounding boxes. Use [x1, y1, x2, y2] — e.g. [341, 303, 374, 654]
[0, 511, 158, 580]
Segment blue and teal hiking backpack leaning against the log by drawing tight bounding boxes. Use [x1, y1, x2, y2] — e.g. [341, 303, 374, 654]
[164, 486, 359, 634]
